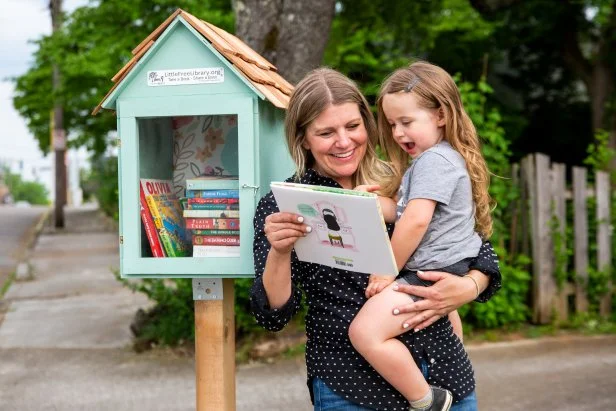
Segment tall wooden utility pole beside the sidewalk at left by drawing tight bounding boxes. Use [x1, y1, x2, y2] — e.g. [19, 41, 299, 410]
[49, 0, 66, 228]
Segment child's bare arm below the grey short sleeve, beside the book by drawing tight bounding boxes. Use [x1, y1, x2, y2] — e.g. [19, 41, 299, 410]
[391, 198, 436, 270]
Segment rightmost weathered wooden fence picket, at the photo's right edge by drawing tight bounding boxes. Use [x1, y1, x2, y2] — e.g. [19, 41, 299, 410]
[595, 171, 612, 316]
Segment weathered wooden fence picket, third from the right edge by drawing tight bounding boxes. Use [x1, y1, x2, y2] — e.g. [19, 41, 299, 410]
[551, 163, 570, 321]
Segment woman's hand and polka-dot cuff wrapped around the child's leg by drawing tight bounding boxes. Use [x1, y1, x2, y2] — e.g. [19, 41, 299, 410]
[394, 241, 502, 330]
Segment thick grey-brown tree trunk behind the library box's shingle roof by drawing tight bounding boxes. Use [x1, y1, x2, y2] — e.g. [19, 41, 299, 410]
[233, 0, 336, 83]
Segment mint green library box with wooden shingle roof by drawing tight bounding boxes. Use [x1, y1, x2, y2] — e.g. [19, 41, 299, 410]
[94, 10, 294, 278]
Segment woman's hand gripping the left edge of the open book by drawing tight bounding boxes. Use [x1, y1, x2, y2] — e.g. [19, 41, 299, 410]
[263, 212, 312, 254]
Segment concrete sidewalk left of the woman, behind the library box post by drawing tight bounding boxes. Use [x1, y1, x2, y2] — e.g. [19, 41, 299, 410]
[0, 206, 312, 411]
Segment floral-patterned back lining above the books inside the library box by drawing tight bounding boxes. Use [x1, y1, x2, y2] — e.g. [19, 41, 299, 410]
[172, 114, 238, 197]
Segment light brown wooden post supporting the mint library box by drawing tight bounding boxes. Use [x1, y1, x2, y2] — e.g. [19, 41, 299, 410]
[193, 278, 235, 411]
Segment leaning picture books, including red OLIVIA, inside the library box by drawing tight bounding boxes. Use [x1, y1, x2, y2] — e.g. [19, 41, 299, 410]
[139, 178, 190, 257]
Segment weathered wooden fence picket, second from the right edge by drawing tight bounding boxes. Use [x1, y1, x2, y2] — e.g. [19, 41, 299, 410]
[573, 167, 588, 313]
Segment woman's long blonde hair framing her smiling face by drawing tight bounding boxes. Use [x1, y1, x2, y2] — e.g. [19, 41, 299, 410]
[285, 68, 398, 197]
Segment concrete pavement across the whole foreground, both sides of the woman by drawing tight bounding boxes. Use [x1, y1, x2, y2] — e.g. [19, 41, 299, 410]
[0, 207, 616, 411]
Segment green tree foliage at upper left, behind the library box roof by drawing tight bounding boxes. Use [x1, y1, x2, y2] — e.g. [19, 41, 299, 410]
[13, 0, 234, 154]
